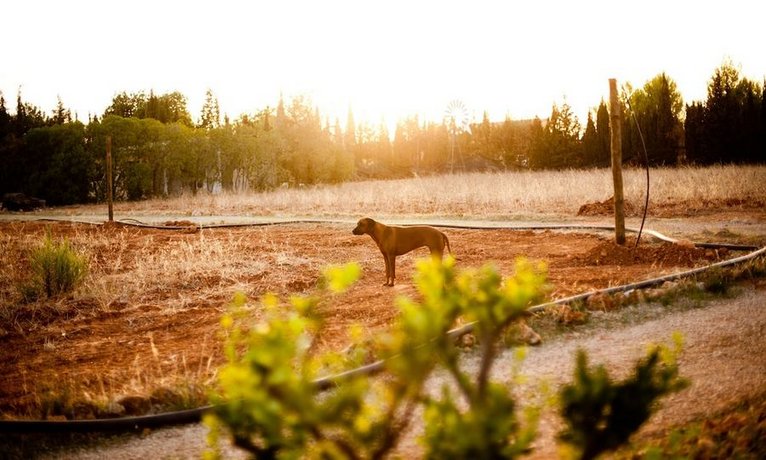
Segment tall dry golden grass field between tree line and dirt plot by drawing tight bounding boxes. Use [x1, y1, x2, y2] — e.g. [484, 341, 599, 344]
[52, 166, 766, 218]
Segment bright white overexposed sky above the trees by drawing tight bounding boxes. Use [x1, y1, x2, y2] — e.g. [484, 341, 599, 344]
[0, 0, 766, 125]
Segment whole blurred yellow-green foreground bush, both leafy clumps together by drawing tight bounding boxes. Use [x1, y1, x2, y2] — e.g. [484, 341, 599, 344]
[207, 258, 544, 458]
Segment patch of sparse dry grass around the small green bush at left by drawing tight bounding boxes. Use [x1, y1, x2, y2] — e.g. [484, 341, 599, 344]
[0, 224, 274, 331]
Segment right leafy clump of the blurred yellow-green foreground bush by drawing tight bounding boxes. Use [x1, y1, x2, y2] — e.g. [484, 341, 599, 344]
[414, 260, 545, 459]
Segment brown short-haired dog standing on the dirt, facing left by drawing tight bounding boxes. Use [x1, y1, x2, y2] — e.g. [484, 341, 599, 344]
[352, 217, 452, 286]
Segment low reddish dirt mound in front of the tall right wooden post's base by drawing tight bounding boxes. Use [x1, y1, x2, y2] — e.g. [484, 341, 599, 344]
[573, 240, 729, 267]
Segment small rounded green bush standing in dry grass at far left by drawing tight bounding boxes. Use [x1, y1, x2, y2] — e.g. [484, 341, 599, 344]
[21, 231, 88, 300]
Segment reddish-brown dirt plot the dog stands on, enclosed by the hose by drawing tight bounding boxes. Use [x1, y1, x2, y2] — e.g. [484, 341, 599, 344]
[0, 216, 760, 418]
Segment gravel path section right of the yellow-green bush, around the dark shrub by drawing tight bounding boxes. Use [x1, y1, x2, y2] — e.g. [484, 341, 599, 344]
[498, 290, 766, 458]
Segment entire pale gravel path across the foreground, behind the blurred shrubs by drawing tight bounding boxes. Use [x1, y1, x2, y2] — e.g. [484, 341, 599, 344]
[39, 288, 766, 460]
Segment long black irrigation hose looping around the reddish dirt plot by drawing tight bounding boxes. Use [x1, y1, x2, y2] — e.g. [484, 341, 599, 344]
[0, 219, 766, 433]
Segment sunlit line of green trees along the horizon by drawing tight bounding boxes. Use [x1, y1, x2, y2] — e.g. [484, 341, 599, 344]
[0, 62, 766, 205]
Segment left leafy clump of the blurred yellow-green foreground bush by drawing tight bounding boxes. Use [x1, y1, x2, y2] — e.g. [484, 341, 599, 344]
[206, 272, 376, 458]
